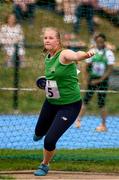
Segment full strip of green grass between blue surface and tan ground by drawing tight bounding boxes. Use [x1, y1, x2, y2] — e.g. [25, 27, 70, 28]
[0, 149, 119, 173]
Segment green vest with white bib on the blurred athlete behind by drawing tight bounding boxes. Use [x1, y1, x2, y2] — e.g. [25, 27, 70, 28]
[89, 49, 108, 78]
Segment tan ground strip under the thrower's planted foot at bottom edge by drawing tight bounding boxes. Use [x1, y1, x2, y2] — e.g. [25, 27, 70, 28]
[2, 171, 119, 180]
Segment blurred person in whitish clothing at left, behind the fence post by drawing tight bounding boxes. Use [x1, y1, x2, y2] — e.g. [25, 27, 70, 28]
[0, 14, 25, 67]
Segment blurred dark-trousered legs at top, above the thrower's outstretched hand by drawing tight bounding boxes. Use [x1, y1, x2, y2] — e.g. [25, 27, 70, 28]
[73, 0, 98, 34]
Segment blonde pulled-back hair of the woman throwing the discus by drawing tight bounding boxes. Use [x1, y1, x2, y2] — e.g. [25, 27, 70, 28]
[42, 27, 62, 52]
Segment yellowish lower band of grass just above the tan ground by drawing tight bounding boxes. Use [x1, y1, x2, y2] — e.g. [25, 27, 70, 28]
[0, 160, 119, 173]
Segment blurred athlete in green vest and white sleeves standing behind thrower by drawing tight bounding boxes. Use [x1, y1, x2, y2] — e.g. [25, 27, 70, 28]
[76, 34, 115, 132]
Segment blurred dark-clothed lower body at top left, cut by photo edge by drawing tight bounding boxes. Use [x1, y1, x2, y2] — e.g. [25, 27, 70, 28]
[13, 0, 36, 25]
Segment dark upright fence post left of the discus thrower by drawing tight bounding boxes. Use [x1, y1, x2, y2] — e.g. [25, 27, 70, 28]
[13, 44, 20, 111]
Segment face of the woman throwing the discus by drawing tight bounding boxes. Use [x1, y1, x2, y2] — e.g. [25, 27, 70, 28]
[43, 30, 60, 51]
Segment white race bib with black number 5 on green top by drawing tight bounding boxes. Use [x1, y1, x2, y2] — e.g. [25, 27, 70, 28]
[45, 80, 60, 99]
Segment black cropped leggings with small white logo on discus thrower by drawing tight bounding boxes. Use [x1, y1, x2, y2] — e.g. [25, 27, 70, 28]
[35, 100, 82, 151]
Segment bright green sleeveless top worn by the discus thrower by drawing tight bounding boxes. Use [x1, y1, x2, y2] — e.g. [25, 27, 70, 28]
[45, 51, 81, 105]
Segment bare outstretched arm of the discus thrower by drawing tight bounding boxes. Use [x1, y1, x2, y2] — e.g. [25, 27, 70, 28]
[60, 49, 95, 63]
